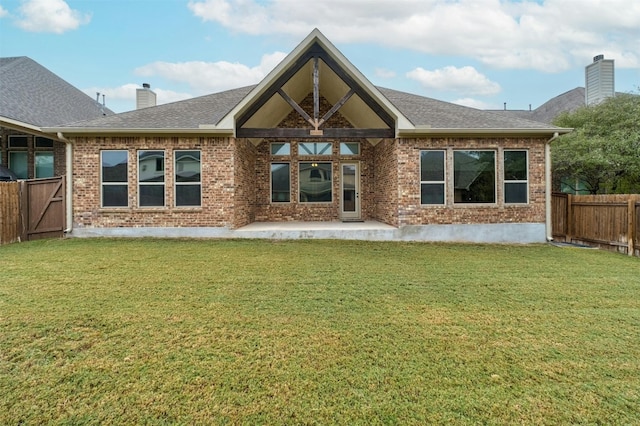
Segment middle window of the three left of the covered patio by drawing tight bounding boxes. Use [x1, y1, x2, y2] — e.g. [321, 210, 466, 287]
[138, 151, 165, 207]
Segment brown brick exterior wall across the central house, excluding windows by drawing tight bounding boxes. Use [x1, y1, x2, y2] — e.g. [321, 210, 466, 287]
[63, 98, 546, 228]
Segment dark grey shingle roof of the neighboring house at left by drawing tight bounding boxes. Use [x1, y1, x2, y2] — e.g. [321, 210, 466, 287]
[0, 56, 113, 127]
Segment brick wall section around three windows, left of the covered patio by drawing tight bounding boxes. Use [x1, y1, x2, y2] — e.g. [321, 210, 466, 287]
[73, 137, 238, 227]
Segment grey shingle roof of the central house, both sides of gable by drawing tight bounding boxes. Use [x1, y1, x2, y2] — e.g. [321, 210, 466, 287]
[55, 82, 550, 130]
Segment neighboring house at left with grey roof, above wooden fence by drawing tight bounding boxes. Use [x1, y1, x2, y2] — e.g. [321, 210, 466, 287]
[0, 56, 113, 179]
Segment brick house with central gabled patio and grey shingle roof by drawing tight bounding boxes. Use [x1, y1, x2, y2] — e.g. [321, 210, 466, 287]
[15, 30, 570, 243]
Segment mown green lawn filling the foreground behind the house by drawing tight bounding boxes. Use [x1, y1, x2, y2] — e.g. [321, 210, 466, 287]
[0, 239, 640, 425]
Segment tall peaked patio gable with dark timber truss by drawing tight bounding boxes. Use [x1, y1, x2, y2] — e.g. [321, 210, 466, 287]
[218, 30, 409, 138]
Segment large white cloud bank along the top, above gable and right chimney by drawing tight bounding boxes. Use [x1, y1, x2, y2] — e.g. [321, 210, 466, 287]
[188, 0, 640, 72]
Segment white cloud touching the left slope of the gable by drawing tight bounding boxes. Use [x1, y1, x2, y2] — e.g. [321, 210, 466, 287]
[134, 52, 286, 94]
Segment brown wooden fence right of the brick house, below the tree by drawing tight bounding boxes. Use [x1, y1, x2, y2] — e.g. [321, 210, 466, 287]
[552, 193, 640, 256]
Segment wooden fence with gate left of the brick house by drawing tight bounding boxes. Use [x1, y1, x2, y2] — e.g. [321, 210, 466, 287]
[0, 177, 65, 244]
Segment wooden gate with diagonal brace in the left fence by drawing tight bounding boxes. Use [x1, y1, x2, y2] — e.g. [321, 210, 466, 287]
[22, 176, 65, 240]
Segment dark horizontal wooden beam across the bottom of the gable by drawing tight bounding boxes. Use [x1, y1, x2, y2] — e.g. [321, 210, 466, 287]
[236, 128, 395, 139]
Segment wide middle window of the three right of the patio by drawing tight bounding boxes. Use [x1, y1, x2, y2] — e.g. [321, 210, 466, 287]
[453, 151, 496, 203]
